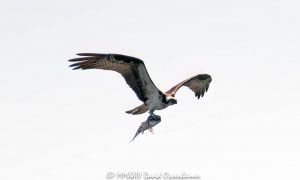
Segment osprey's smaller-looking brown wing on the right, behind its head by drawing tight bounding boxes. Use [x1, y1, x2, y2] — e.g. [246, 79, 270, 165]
[166, 74, 212, 99]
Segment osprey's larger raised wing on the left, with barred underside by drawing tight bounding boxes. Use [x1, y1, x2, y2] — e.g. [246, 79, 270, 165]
[69, 53, 159, 102]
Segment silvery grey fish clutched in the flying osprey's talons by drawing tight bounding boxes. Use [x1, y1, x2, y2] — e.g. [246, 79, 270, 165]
[130, 114, 161, 142]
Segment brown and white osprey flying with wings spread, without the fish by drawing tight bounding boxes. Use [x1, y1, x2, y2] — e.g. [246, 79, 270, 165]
[69, 53, 212, 116]
